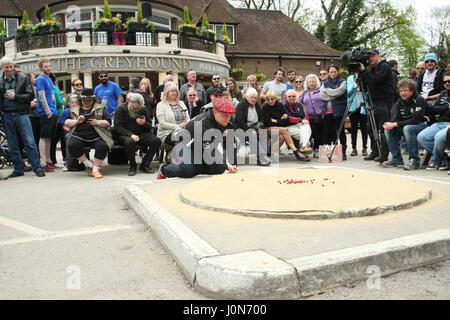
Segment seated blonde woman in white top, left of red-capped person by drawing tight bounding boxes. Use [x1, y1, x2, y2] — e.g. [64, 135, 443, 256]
[156, 82, 190, 145]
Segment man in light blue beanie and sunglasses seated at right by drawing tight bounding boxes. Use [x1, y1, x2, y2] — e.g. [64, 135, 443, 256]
[418, 51, 445, 101]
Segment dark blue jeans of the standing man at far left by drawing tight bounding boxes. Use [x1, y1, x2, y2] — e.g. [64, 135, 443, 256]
[2, 112, 42, 173]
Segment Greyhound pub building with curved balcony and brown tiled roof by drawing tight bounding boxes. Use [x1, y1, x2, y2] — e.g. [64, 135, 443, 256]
[0, 0, 340, 93]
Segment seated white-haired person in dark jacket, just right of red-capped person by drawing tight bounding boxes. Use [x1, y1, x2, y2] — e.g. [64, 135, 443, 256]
[236, 88, 270, 166]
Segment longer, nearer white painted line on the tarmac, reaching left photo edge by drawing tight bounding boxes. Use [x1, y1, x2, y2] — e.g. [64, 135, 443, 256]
[0, 225, 131, 246]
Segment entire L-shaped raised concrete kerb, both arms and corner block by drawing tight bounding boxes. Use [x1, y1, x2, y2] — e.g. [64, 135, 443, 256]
[124, 185, 450, 299]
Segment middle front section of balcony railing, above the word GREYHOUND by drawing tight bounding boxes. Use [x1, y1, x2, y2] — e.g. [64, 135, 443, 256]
[91, 31, 158, 47]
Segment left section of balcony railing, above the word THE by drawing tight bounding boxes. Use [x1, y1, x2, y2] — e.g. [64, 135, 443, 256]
[16, 30, 67, 52]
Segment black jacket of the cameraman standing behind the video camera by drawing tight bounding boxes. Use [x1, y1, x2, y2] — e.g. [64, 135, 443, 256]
[361, 60, 395, 104]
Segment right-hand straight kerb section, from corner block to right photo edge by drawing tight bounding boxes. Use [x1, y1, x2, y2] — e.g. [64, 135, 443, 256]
[288, 229, 450, 296]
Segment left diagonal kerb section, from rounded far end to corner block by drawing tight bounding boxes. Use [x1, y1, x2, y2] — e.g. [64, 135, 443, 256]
[124, 185, 219, 285]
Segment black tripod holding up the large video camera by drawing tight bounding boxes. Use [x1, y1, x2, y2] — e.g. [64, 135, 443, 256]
[328, 77, 381, 162]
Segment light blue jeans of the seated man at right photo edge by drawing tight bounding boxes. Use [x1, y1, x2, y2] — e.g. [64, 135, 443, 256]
[417, 122, 450, 165]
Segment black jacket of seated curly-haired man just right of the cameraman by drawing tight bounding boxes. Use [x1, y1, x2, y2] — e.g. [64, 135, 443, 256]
[391, 93, 427, 127]
